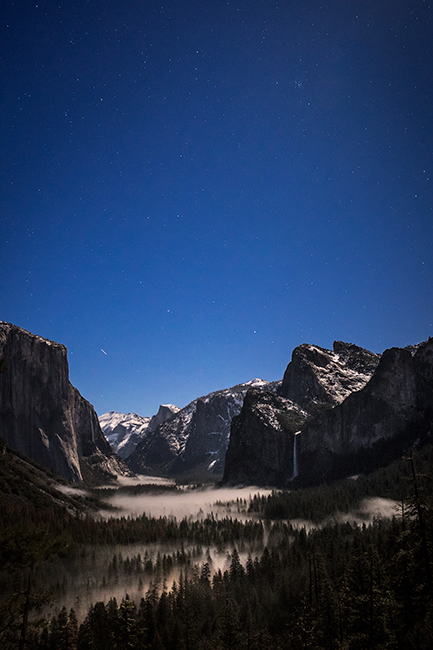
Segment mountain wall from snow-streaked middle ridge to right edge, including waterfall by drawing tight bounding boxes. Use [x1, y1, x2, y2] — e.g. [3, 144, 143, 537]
[98, 341, 433, 487]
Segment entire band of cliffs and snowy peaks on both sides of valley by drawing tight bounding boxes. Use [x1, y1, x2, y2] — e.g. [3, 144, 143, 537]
[0, 322, 433, 487]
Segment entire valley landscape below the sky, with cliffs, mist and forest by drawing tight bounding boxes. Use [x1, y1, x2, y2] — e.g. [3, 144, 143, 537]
[0, 323, 433, 650]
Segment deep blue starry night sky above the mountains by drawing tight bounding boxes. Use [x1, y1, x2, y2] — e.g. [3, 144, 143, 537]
[0, 0, 433, 415]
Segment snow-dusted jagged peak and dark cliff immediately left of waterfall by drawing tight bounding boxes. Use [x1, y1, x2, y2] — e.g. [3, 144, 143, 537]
[223, 341, 380, 486]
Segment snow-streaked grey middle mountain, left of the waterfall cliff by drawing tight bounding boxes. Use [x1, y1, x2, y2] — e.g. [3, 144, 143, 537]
[127, 379, 279, 480]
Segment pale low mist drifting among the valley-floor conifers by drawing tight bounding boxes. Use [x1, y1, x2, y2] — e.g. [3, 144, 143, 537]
[34, 477, 398, 621]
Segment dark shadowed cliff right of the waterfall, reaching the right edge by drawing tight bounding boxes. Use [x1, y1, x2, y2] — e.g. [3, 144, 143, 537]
[299, 339, 433, 480]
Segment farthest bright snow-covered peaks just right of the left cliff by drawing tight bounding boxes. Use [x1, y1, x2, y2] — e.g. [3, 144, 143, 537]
[99, 404, 179, 458]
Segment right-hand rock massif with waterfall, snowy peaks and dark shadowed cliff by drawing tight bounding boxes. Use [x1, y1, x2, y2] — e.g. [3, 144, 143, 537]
[224, 339, 433, 487]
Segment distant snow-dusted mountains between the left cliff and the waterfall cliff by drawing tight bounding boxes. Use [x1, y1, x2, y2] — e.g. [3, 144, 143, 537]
[99, 379, 281, 480]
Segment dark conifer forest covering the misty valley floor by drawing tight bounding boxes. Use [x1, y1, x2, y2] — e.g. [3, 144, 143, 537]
[0, 447, 433, 650]
